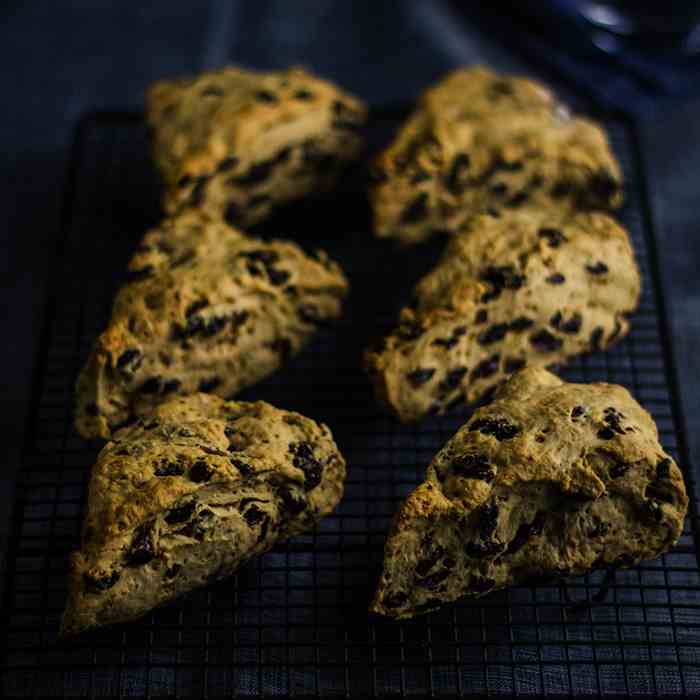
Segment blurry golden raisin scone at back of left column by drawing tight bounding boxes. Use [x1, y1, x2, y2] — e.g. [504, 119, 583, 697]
[147, 67, 367, 227]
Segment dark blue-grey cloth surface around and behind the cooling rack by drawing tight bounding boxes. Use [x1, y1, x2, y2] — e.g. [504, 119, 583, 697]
[0, 0, 700, 532]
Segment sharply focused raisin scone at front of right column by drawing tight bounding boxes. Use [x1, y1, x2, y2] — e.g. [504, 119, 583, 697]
[371, 369, 688, 618]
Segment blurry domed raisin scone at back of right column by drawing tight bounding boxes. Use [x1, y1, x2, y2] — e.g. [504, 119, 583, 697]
[370, 67, 622, 244]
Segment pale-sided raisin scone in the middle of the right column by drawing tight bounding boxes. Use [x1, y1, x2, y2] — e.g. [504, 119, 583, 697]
[365, 208, 640, 422]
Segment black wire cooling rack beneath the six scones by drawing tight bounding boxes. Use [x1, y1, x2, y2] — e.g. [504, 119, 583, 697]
[0, 109, 700, 698]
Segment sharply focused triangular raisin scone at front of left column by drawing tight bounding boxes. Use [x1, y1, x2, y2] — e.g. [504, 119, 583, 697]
[62, 394, 345, 635]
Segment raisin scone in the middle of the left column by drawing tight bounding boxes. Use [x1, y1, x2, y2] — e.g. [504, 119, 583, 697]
[76, 212, 347, 438]
